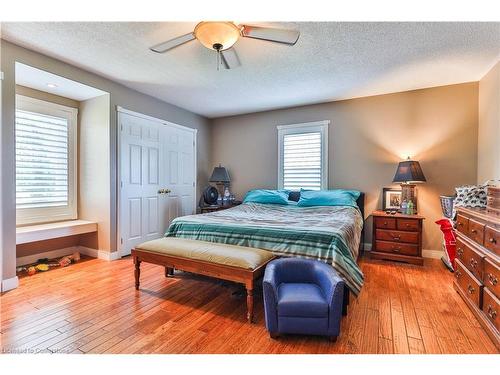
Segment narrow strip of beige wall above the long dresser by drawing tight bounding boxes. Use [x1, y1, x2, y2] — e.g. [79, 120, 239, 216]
[477, 61, 500, 184]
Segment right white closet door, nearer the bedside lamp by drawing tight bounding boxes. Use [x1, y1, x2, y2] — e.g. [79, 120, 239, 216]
[163, 126, 196, 228]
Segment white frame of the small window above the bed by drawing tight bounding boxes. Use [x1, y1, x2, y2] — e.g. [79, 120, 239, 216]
[277, 120, 330, 190]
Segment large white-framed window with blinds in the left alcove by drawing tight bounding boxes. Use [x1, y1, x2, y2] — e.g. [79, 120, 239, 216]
[15, 96, 76, 224]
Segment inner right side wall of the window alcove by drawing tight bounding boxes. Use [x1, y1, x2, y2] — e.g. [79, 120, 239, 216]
[78, 94, 112, 251]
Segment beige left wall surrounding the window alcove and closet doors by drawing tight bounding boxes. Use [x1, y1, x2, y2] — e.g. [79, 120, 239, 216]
[0, 40, 211, 280]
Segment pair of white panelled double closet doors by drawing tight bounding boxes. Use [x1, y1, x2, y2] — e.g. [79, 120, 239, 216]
[118, 108, 196, 256]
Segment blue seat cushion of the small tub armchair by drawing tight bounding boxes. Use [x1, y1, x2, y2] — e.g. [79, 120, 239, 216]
[278, 283, 328, 318]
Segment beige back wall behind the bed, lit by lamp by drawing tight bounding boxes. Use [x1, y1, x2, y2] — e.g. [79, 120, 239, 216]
[212, 83, 478, 250]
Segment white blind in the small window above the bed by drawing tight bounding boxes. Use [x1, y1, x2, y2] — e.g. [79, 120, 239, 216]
[283, 132, 321, 190]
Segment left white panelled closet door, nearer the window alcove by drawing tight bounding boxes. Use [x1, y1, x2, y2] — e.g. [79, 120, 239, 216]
[119, 113, 165, 256]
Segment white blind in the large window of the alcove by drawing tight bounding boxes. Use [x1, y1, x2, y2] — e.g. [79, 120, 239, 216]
[16, 110, 68, 209]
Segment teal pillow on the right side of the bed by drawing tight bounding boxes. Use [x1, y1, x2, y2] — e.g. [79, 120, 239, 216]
[297, 189, 361, 207]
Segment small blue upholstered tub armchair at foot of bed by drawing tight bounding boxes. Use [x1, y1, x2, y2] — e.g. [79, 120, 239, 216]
[263, 258, 344, 341]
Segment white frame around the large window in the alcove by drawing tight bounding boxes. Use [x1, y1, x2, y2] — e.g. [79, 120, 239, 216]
[14, 94, 78, 226]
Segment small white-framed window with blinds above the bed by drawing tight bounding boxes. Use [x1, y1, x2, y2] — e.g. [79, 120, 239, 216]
[278, 121, 328, 190]
